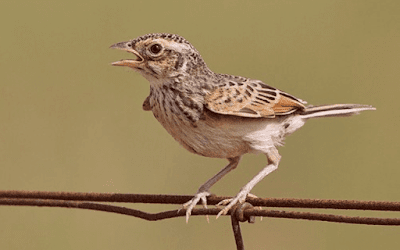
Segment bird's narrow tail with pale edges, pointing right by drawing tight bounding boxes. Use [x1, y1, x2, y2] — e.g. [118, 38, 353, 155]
[300, 104, 375, 119]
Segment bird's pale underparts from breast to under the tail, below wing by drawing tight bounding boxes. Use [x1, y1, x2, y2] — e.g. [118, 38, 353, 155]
[153, 97, 304, 158]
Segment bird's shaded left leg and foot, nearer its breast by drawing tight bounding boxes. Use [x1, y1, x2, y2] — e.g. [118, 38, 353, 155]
[182, 156, 241, 223]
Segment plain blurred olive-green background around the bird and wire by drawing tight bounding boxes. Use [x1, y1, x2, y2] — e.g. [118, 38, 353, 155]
[0, 0, 400, 249]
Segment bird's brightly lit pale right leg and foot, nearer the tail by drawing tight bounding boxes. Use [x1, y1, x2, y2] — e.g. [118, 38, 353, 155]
[217, 148, 281, 219]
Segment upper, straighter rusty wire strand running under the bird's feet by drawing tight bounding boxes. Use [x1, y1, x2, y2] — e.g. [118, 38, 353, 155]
[0, 190, 400, 211]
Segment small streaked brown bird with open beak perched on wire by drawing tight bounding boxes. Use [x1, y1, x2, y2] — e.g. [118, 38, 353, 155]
[110, 33, 375, 222]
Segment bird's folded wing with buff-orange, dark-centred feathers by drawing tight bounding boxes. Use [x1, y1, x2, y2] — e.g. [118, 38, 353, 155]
[205, 78, 306, 118]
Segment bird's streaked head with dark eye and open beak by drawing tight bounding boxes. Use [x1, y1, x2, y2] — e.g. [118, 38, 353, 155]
[110, 33, 208, 82]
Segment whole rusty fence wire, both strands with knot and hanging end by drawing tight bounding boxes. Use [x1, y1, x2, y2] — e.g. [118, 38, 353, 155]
[0, 190, 400, 249]
